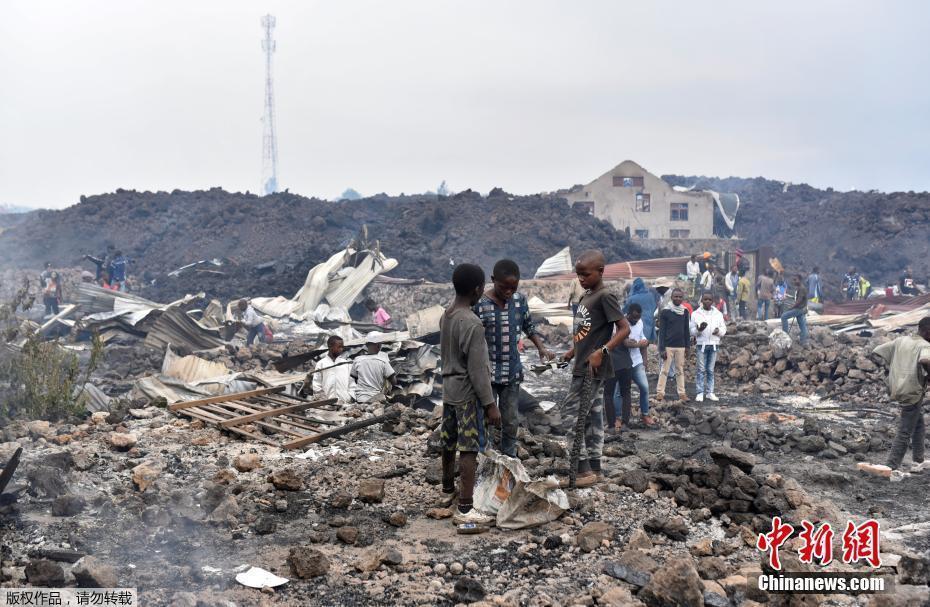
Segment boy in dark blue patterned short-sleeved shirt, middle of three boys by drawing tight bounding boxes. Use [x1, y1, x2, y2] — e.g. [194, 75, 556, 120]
[474, 259, 553, 457]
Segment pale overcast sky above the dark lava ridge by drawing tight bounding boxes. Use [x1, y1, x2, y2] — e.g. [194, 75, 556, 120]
[0, 0, 930, 208]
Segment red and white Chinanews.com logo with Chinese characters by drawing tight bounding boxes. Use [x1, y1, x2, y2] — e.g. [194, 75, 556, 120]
[756, 516, 893, 594]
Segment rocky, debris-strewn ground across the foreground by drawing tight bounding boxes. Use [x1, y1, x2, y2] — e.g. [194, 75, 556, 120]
[0, 276, 930, 607]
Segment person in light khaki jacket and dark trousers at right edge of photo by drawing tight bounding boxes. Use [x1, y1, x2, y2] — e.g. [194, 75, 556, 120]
[873, 316, 930, 472]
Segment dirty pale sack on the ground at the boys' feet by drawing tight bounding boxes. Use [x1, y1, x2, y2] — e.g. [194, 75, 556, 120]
[473, 449, 568, 529]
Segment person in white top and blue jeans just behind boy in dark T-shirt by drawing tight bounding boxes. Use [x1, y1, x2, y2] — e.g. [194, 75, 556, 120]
[605, 302, 655, 430]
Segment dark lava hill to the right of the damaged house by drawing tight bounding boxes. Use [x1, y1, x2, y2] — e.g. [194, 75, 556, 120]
[662, 175, 930, 288]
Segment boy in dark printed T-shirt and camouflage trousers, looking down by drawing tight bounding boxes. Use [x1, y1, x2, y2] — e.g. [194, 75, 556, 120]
[562, 251, 630, 487]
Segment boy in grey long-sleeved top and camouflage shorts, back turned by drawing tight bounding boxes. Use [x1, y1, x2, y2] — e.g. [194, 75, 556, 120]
[439, 263, 501, 525]
